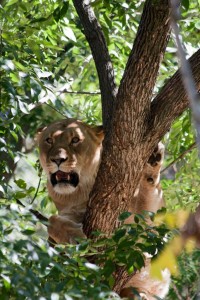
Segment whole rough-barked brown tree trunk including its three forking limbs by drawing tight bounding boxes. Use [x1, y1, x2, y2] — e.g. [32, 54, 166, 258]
[73, 0, 200, 292]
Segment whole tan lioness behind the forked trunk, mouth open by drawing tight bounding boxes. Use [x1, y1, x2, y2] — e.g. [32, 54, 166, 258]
[38, 119, 169, 299]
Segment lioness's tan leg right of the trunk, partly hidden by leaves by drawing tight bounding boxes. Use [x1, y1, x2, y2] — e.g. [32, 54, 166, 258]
[121, 143, 170, 300]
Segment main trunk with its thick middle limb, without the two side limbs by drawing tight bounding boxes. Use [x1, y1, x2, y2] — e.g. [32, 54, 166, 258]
[84, 0, 170, 235]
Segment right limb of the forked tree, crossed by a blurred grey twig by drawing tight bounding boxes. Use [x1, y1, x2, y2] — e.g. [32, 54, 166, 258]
[146, 49, 200, 142]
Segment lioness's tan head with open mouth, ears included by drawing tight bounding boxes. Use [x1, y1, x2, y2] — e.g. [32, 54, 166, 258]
[38, 119, 103, 194]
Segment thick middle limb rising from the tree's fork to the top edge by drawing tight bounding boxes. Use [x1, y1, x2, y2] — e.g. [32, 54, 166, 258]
[115, 0, 170, 135]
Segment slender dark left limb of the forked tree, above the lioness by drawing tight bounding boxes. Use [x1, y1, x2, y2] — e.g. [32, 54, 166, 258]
[73, 0, 117, 130]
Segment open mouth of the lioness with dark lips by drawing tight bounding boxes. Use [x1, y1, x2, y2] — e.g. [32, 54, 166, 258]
[51, 171, 79, 187]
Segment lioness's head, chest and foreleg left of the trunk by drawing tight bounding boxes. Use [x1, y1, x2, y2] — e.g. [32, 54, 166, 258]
[38, 119, 103, 243]
